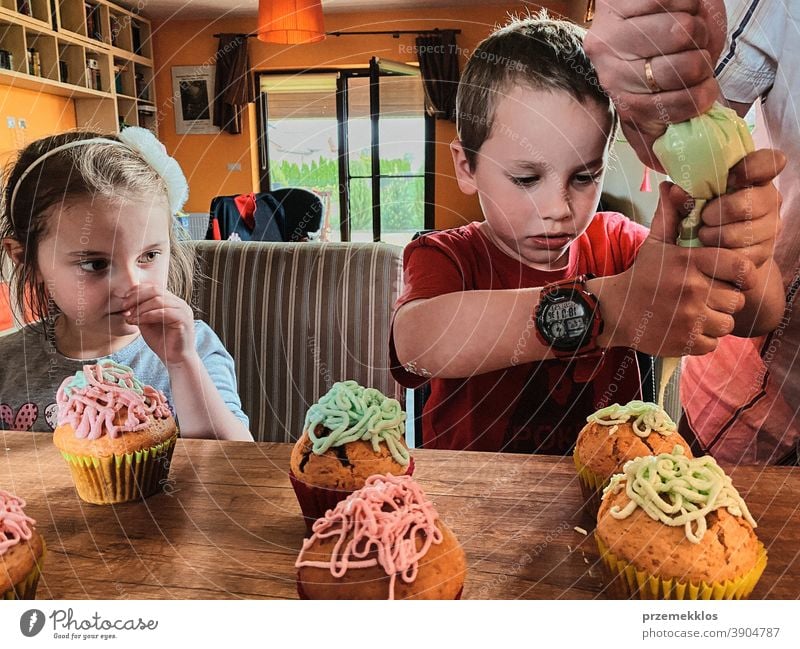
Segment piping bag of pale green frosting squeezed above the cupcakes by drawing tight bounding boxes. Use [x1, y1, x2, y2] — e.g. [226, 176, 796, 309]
[653, 103, 755, 408]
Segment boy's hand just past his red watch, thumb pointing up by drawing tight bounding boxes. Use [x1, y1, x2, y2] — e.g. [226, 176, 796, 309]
[590, 182, 755, 356]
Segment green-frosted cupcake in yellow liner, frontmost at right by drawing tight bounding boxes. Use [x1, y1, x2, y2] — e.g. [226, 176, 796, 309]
[595, 446, 767, 599]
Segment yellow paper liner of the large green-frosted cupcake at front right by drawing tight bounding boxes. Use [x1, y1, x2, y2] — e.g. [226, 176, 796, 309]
[594, 533, 767, 600]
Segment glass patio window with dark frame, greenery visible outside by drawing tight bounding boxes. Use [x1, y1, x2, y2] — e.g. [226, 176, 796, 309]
[259, 59, 434, 245]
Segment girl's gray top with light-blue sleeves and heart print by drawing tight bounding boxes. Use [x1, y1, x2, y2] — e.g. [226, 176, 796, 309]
[0, 320, 249, 432]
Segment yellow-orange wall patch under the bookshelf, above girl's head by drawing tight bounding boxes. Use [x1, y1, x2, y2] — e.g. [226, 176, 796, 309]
[0, 84, 77, 164]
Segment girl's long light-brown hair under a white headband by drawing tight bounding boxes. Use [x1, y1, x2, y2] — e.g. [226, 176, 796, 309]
[0, 131, 195, 321]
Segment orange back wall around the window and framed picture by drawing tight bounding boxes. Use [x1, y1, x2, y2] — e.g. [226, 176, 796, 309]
[153, 1, 577, 228]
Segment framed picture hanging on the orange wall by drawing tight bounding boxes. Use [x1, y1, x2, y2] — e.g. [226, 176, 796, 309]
[172, 65, 219, 135]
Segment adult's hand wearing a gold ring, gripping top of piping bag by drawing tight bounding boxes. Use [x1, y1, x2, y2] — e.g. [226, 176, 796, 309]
[584, 0, 726, 172]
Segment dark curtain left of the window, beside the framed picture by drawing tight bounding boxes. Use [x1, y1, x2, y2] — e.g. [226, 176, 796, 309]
[214, 34, 255, 135]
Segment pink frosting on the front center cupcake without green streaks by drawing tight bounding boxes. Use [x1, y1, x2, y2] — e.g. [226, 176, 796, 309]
[295, 474, 442, 599]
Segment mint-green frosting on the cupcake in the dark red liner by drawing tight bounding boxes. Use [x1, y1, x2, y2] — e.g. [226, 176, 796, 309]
[305, 381, 411, 466]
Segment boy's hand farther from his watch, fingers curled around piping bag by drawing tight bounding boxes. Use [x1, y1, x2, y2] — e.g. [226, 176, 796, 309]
[699, 149, 786, 268]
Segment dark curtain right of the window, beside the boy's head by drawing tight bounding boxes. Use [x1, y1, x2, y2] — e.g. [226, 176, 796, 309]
[417, 29, 459, 122]
